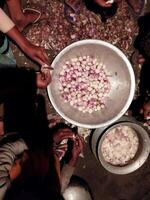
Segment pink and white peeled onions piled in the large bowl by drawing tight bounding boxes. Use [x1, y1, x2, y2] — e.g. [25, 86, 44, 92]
[59, 56, 110, 113]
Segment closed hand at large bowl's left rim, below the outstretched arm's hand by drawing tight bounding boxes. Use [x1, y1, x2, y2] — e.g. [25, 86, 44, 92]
[36, 70, 51, 89]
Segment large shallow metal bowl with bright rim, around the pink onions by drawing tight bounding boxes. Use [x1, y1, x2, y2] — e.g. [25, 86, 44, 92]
[47, 40, 135, 128]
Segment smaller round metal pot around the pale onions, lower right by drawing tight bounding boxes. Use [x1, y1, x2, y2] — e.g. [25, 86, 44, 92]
[97, 122, 150, 174]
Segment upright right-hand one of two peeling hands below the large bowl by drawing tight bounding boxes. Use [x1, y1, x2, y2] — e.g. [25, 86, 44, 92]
[68, 135, 84, 167]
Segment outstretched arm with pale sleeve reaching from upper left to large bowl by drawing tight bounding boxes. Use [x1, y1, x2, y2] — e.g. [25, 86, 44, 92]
[0, 8, 48, 65]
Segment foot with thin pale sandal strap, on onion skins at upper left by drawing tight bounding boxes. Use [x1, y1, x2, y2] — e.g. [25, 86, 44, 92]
[13, 9, 48, 31]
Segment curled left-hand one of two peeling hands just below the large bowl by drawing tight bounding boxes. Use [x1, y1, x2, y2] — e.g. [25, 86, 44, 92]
[53, 128, 74, 144]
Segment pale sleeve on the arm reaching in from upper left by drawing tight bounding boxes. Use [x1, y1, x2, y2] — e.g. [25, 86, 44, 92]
[0, 8, 15, 33]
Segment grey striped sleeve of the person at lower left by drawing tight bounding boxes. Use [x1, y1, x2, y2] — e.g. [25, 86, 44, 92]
[0, 139, 27, 199]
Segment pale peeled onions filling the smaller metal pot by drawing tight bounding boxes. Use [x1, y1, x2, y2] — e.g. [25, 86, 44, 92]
[101, 125, 139, 166]
